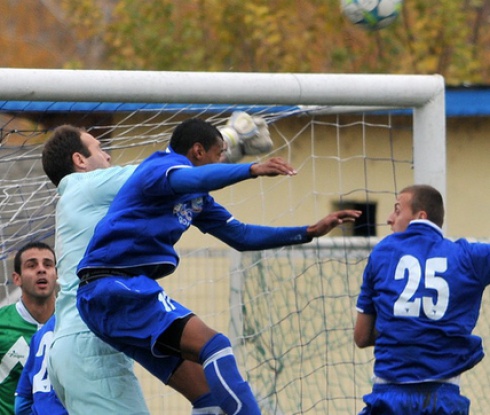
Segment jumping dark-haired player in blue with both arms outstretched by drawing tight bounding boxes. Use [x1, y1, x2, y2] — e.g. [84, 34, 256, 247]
[77, 118, 361, 415]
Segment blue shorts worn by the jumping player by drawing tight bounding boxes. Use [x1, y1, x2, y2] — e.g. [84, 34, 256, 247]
[77, 275, 191, 384]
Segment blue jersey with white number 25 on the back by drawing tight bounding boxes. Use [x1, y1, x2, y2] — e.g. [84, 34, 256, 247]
[357, 221, 490, 383]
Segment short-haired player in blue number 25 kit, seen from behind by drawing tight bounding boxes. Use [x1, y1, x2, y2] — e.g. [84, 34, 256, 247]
[355, 185, 490, 415]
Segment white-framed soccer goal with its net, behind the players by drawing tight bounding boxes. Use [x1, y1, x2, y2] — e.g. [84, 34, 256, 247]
[0, 69, 470, 415]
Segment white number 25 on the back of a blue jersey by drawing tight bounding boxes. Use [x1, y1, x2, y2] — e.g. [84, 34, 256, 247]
[393, 255, 449, 320]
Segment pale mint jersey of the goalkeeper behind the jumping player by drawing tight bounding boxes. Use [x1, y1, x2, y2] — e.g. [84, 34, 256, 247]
[54, 166, 136, 339]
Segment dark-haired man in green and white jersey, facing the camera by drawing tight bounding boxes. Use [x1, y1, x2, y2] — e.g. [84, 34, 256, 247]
[0, 242, 57, 415]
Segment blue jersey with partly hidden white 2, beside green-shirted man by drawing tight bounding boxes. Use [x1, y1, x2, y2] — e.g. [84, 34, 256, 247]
[15, 316, 68, 415]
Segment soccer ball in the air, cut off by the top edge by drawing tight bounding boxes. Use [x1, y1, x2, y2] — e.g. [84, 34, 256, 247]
[340, 0, 403, 30]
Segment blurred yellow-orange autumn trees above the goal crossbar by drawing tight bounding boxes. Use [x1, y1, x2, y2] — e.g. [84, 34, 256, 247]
[0, 0, 490, 85]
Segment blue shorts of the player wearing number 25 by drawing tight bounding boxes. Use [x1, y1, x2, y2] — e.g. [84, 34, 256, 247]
[359, 382, 470, 415]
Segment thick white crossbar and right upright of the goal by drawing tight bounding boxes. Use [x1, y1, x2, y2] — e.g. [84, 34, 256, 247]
[0, 69, 446, 198]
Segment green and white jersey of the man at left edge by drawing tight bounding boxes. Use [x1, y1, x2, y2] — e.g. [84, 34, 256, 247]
[0, 301, 42, 415]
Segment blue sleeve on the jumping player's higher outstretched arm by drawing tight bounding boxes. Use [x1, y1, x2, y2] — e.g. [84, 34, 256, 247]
[167, 163, 253, 193]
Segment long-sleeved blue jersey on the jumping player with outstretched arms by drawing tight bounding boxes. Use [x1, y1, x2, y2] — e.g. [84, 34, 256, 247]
[78, 149, 311, 278]
